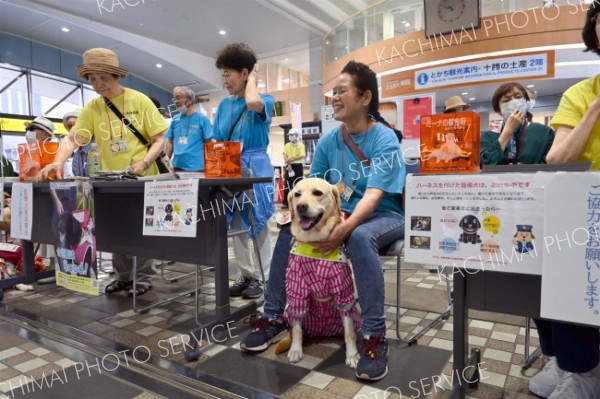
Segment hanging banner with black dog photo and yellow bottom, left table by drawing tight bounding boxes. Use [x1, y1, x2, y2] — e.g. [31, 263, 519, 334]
[50, 181, 100, 295]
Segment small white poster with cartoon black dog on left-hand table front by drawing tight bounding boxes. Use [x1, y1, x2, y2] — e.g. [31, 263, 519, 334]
[143, 179, 198, 237]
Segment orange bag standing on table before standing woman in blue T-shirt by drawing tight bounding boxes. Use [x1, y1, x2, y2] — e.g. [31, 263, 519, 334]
[204, 106, 248, 177]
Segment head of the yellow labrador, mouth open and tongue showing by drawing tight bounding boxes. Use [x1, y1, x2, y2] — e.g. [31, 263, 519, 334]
[288, 178, 342, 242]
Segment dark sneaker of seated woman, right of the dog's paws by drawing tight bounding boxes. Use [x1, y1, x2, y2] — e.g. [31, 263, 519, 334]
[356, 335, 389, 381]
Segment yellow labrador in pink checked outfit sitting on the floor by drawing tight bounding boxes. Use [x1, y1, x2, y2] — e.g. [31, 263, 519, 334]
[285, 178, 361, 368]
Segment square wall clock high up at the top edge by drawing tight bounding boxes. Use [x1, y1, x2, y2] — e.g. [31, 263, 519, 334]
[424, 0, 480, 36]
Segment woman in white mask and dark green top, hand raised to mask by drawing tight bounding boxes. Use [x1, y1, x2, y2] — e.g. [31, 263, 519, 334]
[481, 82, 554, 165]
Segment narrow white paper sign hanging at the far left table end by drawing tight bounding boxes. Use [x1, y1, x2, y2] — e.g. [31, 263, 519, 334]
[10, 183, 33, 240]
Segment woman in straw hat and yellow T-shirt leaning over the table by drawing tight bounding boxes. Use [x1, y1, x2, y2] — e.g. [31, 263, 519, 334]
[38, 48, 168, 294]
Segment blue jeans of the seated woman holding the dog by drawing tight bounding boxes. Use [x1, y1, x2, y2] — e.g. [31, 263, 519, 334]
[264, 212, 404, 335]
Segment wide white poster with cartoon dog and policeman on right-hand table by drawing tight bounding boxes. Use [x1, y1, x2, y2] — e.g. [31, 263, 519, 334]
[404, 173, 545, 274]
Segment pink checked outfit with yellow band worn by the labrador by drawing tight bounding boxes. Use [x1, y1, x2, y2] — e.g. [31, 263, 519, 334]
[284, 243, 362, 337]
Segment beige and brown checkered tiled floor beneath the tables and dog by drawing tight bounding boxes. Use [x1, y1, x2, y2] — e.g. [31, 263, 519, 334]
[0, 216, 542, 399]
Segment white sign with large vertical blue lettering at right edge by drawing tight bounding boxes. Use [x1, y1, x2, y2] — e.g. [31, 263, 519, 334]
[541, 172, 600, 326]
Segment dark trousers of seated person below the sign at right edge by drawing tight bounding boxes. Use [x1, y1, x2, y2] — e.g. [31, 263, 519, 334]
[533, 319, 600, 373]
